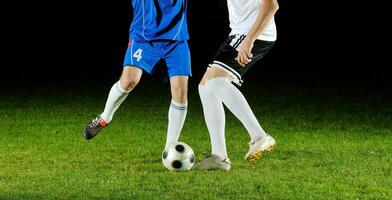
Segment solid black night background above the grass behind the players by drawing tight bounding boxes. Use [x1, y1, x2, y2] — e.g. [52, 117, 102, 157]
[0, 0, 390, 86]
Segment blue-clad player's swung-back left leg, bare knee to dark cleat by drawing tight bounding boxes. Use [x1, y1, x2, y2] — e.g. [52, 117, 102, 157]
[84, 66, 143, 140]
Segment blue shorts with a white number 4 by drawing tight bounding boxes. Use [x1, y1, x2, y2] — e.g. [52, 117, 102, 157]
[124, 40, 192, 77]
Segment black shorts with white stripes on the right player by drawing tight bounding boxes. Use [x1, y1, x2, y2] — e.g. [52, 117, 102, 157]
[209, 35, 275, 86]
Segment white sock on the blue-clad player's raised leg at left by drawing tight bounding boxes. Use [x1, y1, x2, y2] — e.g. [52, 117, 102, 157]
[101, 81, 130, 123]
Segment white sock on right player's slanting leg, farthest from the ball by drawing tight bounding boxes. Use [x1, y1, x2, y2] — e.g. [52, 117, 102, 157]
[206, 77, 267, 140]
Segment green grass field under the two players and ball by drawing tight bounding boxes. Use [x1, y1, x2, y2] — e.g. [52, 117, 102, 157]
[0, 79, 392, 199]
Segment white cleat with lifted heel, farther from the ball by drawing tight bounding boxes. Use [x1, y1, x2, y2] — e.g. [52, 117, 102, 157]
[245, 135, 276, 161]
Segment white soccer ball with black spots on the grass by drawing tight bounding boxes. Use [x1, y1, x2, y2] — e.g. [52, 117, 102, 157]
[162, 142, 195, 171]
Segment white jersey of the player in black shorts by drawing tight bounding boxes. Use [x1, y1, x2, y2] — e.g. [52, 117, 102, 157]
[227, 0, 276, 41]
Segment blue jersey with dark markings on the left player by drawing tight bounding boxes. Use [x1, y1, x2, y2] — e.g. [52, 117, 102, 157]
[130, 0, 189, 41]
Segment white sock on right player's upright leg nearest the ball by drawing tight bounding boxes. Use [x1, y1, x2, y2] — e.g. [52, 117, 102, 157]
[199, 85, 228, 159]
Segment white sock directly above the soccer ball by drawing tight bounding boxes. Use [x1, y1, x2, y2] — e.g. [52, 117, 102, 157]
[166, 100, 188, 147]
